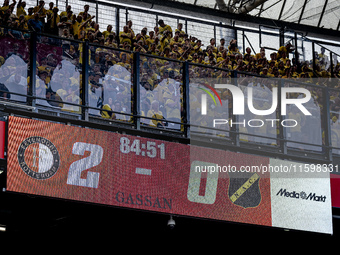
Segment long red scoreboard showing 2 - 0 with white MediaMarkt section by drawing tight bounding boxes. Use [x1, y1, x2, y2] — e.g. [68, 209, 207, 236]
[7, 117, 332, 233]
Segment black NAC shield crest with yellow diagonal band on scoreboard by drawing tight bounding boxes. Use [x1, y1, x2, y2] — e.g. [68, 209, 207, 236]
[228, 172, 261, 208]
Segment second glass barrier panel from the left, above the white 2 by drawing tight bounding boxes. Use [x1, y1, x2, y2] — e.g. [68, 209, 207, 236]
[36, 36, 82, 114]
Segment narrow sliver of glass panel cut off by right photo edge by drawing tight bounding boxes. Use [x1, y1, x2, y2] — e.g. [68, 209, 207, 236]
[329, 89, 340, 155]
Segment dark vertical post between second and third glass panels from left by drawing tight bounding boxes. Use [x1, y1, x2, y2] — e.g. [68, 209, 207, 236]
[81, 40, 89, 121]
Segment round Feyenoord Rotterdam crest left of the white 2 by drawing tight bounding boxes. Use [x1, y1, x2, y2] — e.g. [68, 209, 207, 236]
[18, 136, 60, 180]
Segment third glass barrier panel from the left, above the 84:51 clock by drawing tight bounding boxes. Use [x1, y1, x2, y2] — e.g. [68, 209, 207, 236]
[89, 44, 133, 122]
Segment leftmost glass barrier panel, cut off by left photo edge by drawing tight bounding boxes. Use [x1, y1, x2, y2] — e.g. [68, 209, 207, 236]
[0, 29, 30, 103]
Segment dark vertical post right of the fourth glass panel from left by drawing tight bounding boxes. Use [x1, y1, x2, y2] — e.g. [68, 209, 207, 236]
[183, 61, 190, 138]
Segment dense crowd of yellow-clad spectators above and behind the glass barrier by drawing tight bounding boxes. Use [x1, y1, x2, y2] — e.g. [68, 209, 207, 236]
[0, 0, 340, 151]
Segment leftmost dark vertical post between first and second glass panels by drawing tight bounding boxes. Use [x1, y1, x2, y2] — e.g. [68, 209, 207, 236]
[26, 32, 37, 106]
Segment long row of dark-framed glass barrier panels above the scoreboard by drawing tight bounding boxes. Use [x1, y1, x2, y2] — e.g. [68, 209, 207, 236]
[0, 25, 340, 162]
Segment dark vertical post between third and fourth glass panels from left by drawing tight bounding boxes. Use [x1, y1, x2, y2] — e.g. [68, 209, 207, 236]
[132, 52, 141, 130]
